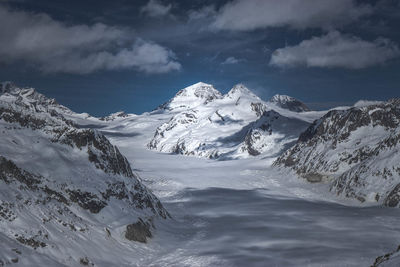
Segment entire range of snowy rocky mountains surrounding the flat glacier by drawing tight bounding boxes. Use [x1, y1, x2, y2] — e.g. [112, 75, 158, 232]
[0, 82, 400, 266]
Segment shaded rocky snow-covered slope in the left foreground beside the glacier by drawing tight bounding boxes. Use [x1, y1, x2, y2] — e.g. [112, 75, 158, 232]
[0, 83, 169, 266]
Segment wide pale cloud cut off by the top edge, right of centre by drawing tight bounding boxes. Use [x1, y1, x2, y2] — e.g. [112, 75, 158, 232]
[212, 0, 372, 31]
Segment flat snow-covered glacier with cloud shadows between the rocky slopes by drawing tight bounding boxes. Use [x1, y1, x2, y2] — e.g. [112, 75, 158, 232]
[91, 108, 400, 266]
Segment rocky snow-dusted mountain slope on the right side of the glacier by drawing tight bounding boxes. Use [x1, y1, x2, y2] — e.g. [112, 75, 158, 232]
[275, 99, 400, 207]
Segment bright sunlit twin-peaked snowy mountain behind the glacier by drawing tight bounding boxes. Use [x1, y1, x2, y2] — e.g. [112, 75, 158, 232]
[148, 83, 318, 158]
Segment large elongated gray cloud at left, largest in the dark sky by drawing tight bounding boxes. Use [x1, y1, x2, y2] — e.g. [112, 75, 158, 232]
[0, 6, 181, 74]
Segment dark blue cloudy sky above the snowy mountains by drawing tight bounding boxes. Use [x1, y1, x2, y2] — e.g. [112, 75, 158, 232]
[0, 0, 400, 116]
